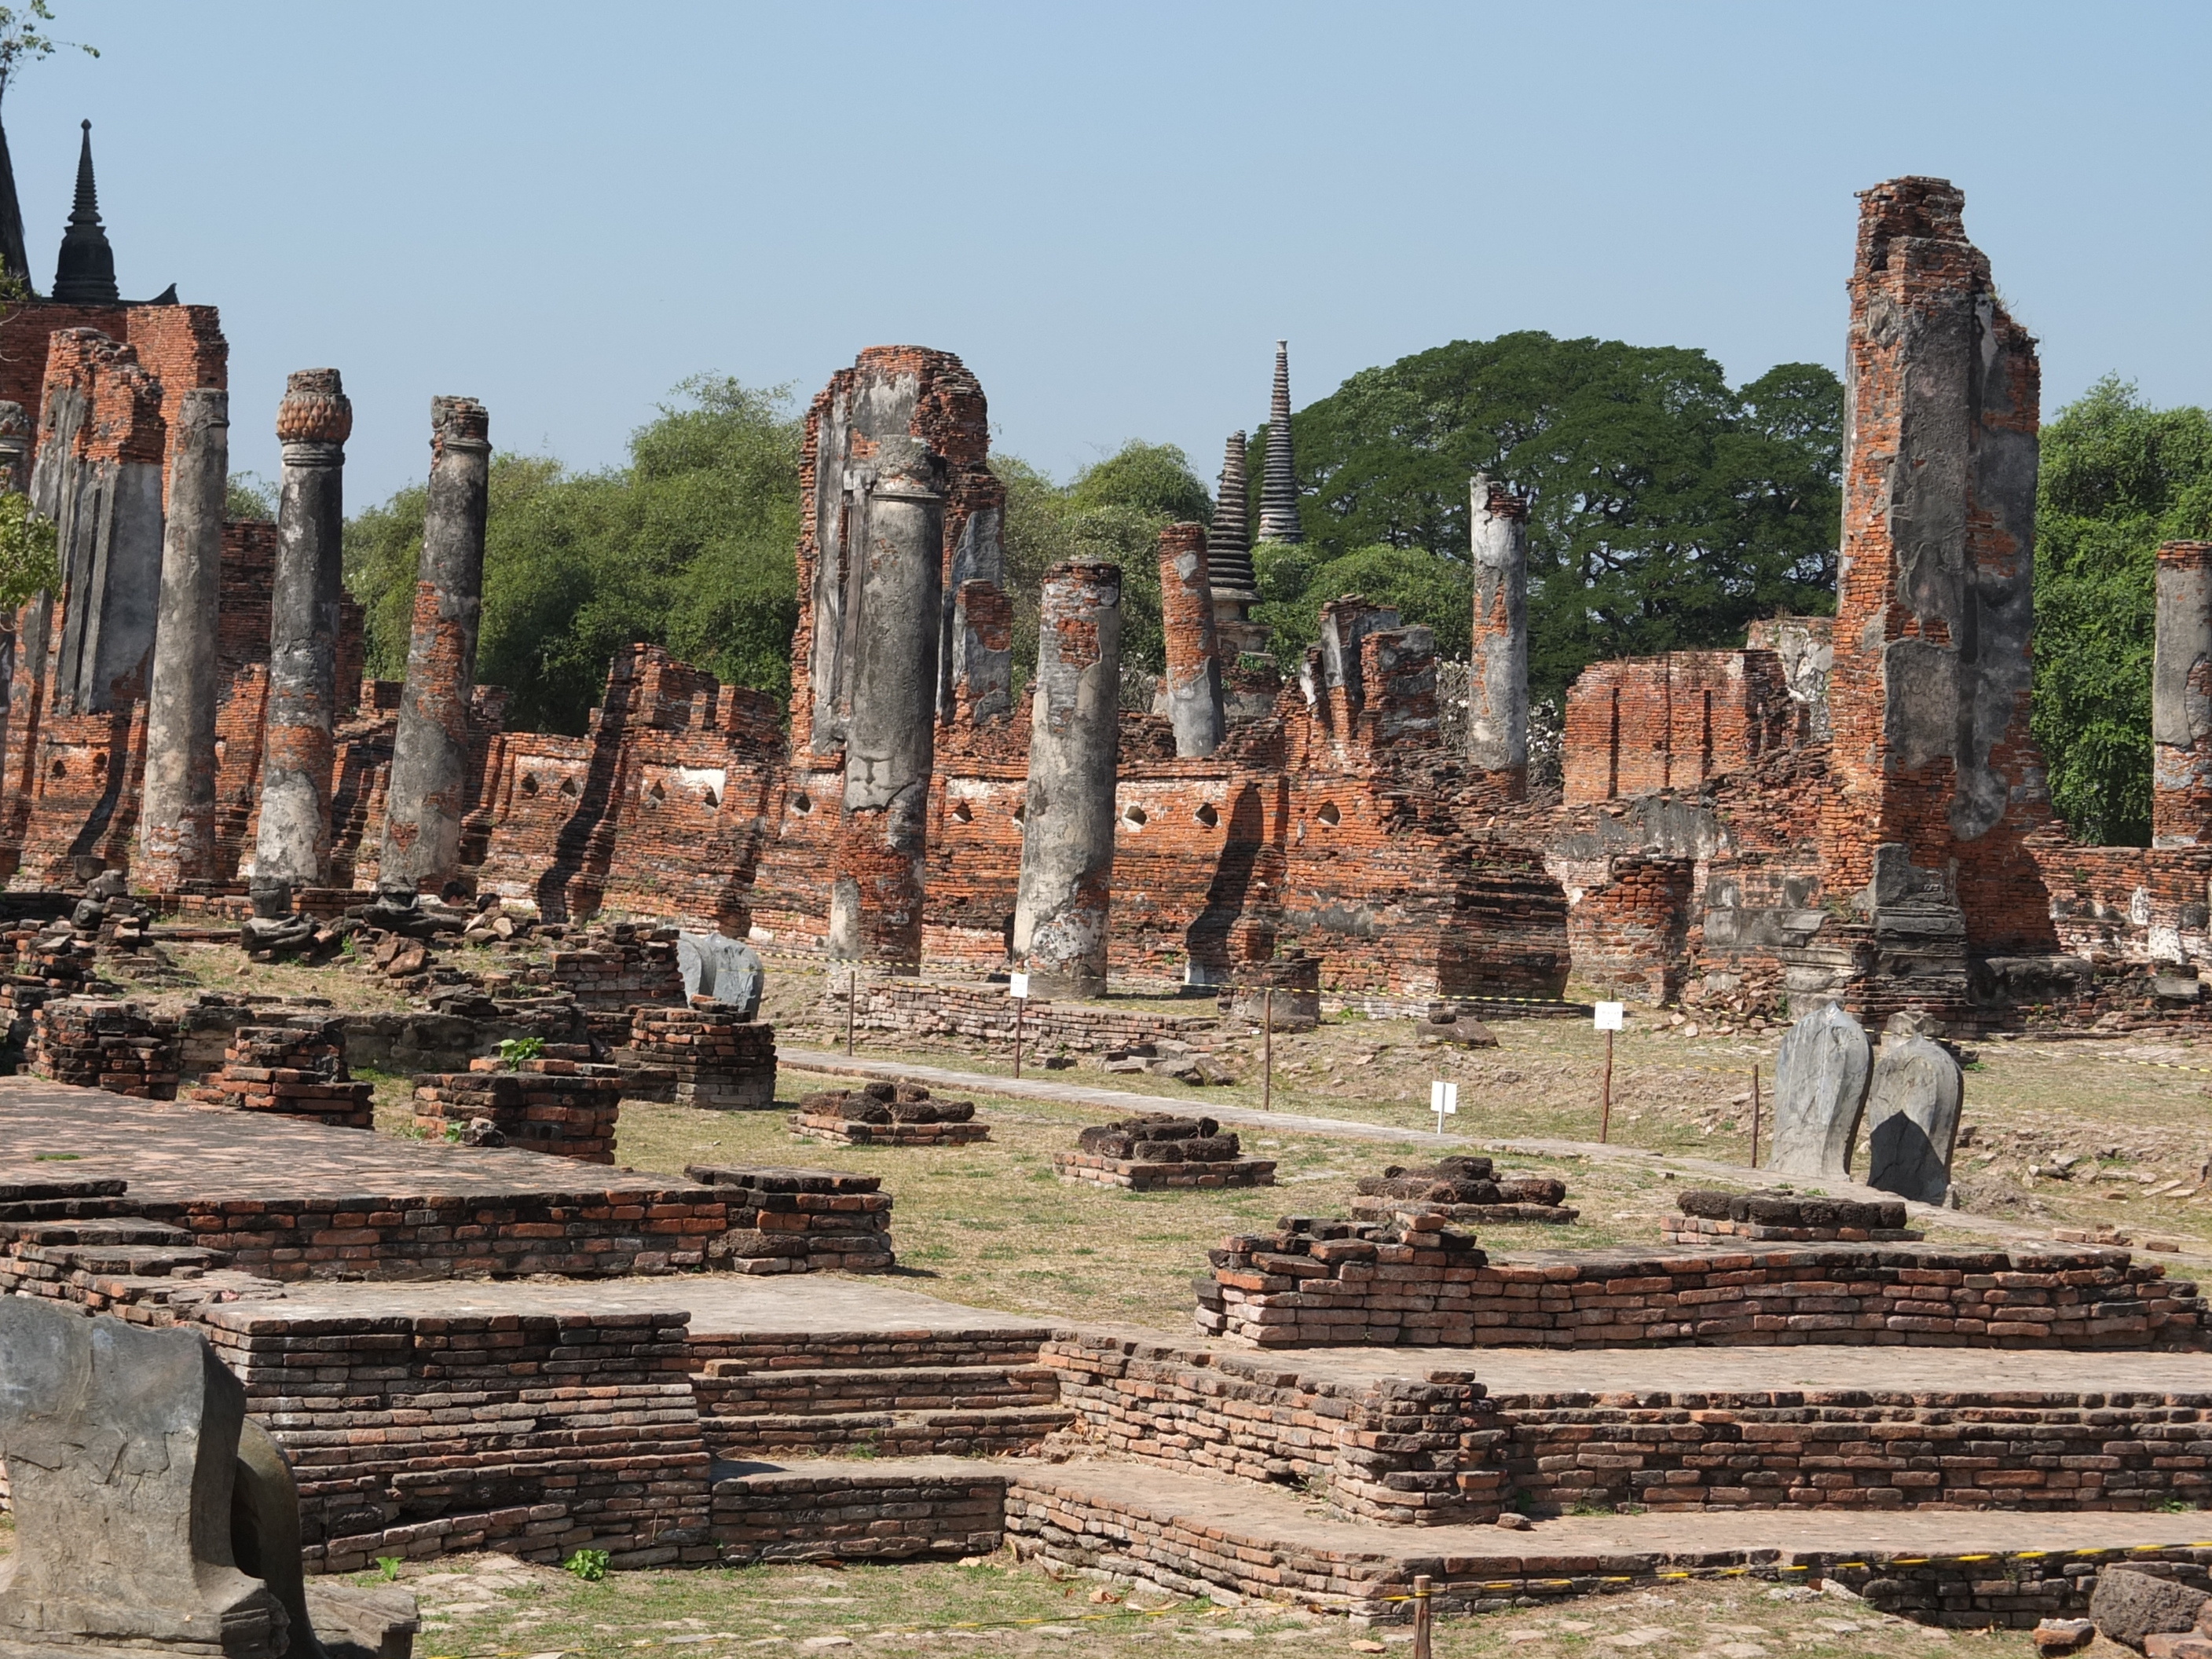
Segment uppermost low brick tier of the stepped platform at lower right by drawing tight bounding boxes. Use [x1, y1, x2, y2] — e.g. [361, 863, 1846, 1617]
[1195, 1223, 2206, 1350]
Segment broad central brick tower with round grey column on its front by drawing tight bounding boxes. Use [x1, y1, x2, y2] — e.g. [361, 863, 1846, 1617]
[792, 345, 1011, 971]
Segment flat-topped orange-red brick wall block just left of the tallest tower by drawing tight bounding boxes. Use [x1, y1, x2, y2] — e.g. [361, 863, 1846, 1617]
[1564, 650, 1805, 803]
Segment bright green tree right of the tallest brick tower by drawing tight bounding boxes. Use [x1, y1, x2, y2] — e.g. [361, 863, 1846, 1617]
[2033, 376, 2212, 848]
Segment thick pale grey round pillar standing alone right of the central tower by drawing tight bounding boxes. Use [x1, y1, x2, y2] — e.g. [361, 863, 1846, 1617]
[1013, 559, 1122, 998]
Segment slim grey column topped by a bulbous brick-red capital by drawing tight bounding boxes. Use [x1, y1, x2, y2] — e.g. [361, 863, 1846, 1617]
[252, 369, 354, 916]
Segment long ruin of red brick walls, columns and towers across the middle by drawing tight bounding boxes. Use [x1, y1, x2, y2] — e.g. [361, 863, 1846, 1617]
[0, 162, 2212, 1024]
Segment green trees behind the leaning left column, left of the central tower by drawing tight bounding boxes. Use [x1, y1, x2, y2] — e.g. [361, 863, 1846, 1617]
[345, 379, 800, 732]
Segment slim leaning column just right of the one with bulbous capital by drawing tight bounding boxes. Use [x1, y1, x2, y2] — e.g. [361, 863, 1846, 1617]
[376, 398, 491, 898]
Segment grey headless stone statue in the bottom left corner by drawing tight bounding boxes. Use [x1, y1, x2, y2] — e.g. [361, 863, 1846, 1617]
[0, 1296, 414, 1659]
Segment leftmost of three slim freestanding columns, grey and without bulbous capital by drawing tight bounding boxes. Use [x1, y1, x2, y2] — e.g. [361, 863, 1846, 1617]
[135, 387, 230, 892]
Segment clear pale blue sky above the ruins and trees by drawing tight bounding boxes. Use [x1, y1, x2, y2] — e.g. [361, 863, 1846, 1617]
[5, 0, 2212, 507]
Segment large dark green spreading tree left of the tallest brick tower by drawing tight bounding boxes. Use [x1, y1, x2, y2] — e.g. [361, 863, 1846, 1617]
[1250, 331, 1843, 697]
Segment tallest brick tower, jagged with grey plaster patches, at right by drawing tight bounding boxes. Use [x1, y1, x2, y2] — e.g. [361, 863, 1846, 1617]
[1821, 179, 2053, 1009]
